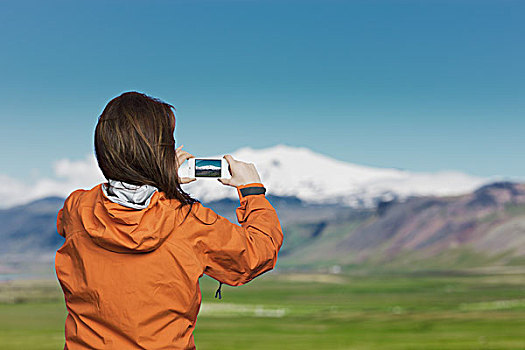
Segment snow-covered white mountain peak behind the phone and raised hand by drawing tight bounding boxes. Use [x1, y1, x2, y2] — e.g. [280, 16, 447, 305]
[180, 145, 494, 207]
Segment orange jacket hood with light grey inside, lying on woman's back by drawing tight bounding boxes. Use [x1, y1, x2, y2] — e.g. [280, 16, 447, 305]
[75, 183, 181, 253]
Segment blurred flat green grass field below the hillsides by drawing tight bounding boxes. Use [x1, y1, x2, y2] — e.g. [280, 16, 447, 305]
[0, 271, 525, 350]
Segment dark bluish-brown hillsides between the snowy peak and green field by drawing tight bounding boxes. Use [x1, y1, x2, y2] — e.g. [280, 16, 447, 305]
[0, 182, 525, 273]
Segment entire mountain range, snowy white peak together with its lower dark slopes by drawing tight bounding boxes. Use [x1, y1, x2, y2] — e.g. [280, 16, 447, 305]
[0, 146, 525, 277]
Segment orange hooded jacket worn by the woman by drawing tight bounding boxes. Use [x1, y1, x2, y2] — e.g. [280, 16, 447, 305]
[55, 183, 283, 350]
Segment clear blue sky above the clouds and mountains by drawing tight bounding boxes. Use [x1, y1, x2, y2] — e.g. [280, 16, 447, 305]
[0, 0, 525, 181]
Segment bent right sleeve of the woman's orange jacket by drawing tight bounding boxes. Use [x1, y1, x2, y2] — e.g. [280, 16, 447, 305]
[190, 183, 284, 286]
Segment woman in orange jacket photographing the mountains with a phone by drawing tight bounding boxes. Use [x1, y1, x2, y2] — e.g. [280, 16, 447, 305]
[55, 92, 283, 350]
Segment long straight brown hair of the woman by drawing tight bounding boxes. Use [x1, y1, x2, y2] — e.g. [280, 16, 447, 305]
[95, 91, 197, 211]
